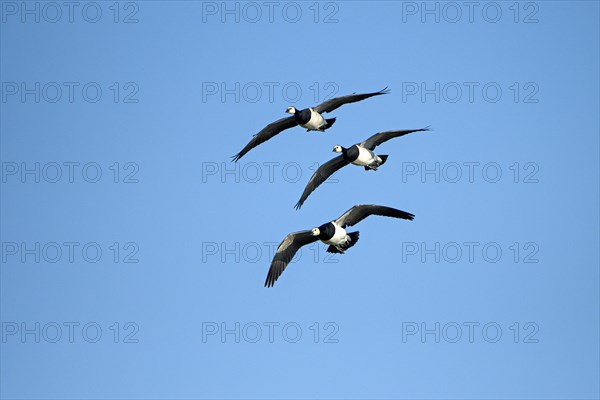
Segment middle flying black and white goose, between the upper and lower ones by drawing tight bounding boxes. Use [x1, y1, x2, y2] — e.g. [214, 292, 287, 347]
[295, 127, 429, 209]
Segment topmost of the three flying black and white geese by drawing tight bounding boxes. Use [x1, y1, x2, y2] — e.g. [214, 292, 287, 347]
[233, 88, 389, 161]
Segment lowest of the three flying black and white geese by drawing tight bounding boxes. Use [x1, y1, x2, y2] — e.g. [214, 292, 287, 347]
[265, 204, 415, 287]
